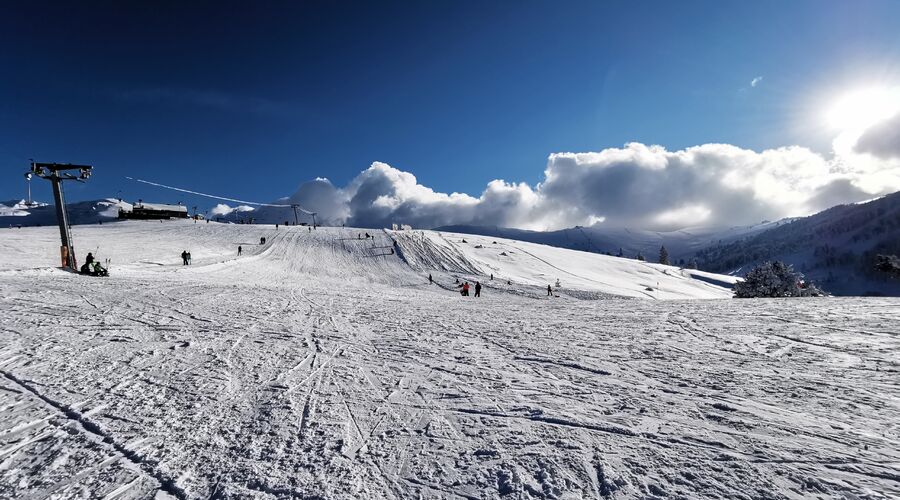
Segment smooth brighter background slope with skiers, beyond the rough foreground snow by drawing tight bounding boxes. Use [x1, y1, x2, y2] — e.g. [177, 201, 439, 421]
[0, 220, 735, 299]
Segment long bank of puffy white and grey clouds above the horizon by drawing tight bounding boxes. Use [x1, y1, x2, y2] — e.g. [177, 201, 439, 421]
[221, 127, 900, 230]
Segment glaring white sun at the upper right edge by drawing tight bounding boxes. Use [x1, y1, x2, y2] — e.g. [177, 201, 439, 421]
[826, 87, 900, 131]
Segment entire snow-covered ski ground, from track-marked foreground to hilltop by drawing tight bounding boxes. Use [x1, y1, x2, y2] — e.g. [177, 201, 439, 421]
[0, 221, 900, 499]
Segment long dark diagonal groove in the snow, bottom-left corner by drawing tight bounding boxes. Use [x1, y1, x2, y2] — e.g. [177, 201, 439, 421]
[0, 370, 189, 500]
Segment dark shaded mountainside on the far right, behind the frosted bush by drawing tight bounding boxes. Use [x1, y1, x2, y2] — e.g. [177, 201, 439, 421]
[696, 192, 900, 296]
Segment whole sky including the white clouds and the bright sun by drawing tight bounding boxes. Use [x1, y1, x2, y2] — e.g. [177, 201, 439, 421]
[0, 1, 900, 229]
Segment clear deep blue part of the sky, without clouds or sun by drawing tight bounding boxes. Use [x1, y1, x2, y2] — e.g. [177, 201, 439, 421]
[0, 1, 900, 219]
